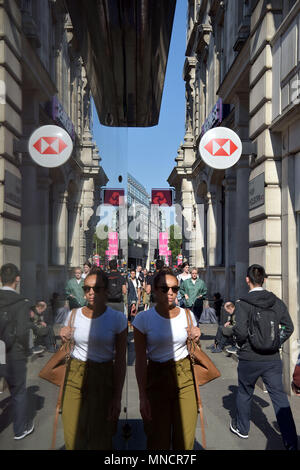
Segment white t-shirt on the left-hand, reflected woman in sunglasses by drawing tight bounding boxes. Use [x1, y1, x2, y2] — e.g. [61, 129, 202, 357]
[64, 307, 127, 362]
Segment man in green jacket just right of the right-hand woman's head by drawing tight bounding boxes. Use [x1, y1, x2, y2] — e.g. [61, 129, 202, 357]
[180, 268, 207, 322]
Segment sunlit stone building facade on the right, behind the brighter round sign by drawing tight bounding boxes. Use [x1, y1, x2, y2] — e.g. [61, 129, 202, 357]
[168, 0, 300, 391]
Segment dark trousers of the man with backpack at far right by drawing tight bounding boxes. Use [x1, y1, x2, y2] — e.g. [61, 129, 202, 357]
[236, 360, 298, 449]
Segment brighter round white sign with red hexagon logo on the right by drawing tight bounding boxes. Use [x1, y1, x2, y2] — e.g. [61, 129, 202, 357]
[199, 127, 242, 170]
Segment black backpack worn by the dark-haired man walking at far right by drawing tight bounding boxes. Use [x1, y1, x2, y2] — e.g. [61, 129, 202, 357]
[248, 305, 280, 353]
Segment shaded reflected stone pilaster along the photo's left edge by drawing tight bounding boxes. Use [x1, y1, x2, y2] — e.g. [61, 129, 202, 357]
[0, 0, 23, 276]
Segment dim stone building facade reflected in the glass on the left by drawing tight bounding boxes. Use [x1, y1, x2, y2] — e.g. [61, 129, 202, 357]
[0, 0, 107, 300]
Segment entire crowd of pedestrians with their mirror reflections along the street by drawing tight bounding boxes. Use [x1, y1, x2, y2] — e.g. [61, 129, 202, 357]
[0, 260, 299, 450]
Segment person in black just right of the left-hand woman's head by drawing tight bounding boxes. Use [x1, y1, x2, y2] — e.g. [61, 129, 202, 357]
[107, 260, 127, 313]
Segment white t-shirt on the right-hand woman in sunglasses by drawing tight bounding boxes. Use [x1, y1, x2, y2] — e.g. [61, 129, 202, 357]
[132, 307, 197, 362]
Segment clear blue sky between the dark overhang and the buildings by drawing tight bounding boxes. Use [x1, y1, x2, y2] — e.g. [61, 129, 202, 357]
[93, 0, 187, 193]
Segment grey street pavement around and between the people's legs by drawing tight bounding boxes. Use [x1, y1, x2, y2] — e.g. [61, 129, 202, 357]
[0, 324, 300, 451]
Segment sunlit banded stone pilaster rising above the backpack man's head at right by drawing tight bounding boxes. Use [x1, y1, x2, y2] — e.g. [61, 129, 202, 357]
[249, 0, 282, 297]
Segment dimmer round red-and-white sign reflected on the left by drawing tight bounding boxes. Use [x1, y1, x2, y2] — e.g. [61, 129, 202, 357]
[28, 126, 73, 168]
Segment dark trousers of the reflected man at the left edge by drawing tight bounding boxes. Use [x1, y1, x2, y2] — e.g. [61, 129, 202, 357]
[5, 358, 30, 436]
